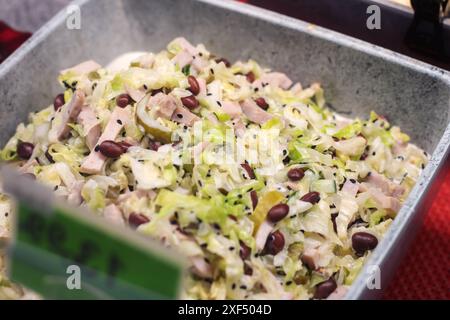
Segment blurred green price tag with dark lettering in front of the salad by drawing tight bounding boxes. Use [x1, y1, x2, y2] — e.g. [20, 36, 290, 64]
[3, 168, 184, 299]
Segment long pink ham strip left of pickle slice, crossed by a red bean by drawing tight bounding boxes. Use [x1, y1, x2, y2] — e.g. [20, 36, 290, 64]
[80, 107, 131, 174]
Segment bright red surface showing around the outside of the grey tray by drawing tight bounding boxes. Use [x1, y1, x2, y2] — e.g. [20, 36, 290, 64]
[0, 0, 450, 300]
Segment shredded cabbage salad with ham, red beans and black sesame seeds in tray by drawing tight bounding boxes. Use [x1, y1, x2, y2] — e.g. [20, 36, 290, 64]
[0, 38, 428, 299]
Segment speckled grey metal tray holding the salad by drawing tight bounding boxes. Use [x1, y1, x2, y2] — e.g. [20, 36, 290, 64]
[0, 0, 450, 299]
